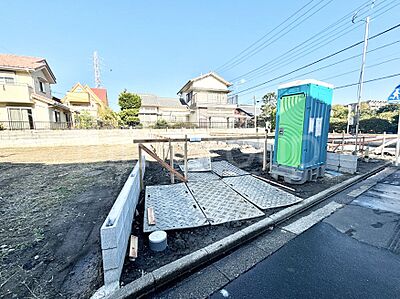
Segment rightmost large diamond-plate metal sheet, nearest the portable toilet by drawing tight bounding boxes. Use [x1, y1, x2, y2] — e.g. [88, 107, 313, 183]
[222, 175, 302, 210]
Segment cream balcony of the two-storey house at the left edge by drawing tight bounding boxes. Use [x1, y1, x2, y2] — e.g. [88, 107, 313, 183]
[0, 83, 32, 104]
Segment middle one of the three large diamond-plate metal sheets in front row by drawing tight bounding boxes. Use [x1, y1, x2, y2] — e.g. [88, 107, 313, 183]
[187, 180, 264, 225]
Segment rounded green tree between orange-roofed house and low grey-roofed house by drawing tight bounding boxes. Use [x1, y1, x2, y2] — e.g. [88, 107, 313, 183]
[118, 89, 142, 126]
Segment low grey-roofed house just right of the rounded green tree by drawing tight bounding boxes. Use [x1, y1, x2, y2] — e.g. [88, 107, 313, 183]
[139, 94, 190, 126]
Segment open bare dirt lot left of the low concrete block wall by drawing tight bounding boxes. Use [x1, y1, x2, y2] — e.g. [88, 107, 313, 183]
[0, 147, 135, 298]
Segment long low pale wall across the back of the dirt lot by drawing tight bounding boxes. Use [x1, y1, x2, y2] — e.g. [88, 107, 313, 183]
[0, 129, 260, 148]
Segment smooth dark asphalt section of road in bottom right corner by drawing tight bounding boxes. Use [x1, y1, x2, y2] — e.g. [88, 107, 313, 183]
[211, 222, 400, 298]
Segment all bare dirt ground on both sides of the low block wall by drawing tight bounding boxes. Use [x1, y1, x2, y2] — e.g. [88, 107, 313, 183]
[0, 142, 384, 298]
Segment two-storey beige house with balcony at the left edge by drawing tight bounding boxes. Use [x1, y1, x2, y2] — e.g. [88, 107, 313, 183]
[0, 54, 71, 129]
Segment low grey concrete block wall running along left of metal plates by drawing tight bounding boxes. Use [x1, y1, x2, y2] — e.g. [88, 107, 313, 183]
[100, 158, 146, 290]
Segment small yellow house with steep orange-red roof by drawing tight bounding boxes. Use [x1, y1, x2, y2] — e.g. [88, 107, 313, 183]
[62, 82, 108, 119]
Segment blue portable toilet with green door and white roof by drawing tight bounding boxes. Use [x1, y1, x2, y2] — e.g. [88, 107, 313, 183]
[271, 80, 333, 184]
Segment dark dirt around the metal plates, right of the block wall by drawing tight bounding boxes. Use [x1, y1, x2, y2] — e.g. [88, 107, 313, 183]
[121, 145, 382, 284]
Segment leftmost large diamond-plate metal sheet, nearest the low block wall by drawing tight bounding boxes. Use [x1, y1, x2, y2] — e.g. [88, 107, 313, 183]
[143, 183, 209, 232]
